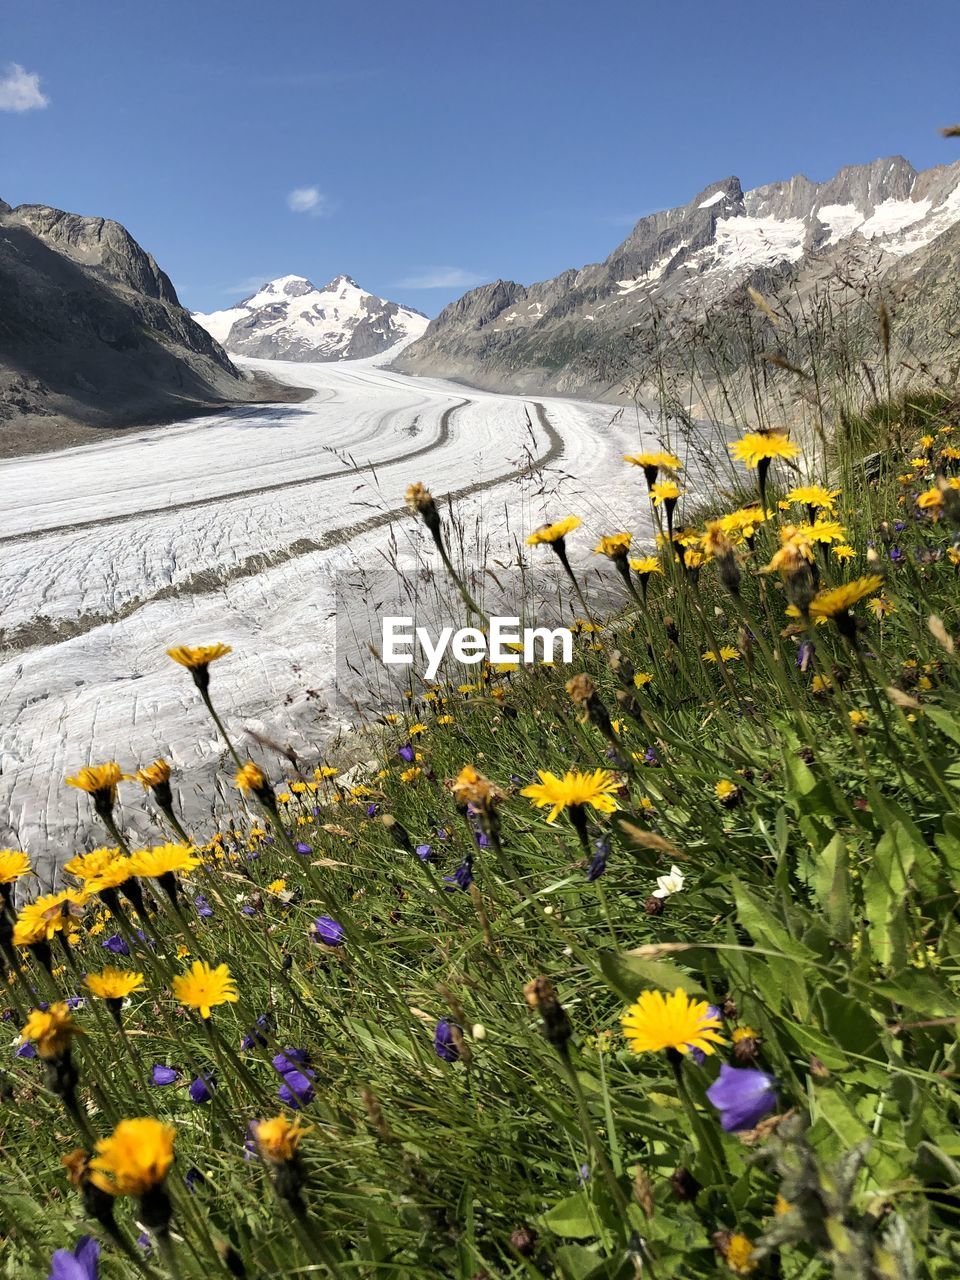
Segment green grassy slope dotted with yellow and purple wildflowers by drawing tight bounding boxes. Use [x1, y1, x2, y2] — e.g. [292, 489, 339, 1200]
[0, 353, 960, 1280]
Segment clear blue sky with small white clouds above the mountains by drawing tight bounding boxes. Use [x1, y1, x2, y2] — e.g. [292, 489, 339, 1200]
[0, 0, 960, 315]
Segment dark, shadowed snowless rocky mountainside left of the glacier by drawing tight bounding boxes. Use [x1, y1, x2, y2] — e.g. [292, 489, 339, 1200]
[0, 201, 296, 454]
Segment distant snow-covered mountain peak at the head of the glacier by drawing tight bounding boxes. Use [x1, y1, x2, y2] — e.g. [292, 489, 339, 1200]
[193, 275, 428, 362]
